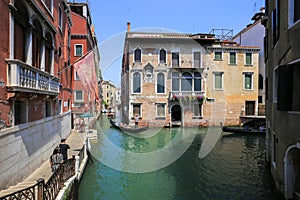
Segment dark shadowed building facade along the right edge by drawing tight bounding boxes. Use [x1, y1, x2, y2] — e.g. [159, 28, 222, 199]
[262, 0, 300, 199]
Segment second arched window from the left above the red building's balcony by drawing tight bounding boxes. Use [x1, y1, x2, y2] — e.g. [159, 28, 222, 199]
[32, 20, 43, 69]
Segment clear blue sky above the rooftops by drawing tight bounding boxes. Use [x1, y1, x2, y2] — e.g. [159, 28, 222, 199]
[89, 0, 265, 85]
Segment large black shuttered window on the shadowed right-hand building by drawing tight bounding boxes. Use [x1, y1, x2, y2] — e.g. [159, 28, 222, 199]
[277, 62, 300, 111]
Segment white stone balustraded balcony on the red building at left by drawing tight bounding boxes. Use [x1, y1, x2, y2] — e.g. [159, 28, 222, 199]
[6, 60, 59, 95]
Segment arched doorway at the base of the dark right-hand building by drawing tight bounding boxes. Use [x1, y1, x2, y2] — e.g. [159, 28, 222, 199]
[284, 144, 300, 199]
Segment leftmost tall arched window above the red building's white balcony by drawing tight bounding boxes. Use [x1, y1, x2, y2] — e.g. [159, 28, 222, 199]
[14, 1, 29, 62]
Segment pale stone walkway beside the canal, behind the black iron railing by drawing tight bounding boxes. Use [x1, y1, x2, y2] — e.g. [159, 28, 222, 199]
[0, 130, 86, 197]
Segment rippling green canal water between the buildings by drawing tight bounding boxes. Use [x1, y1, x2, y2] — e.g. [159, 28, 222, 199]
[79, 117, 279, 200]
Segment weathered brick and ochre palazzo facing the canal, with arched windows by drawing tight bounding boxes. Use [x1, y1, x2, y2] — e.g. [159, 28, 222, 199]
[121, 24, 259, 127]
